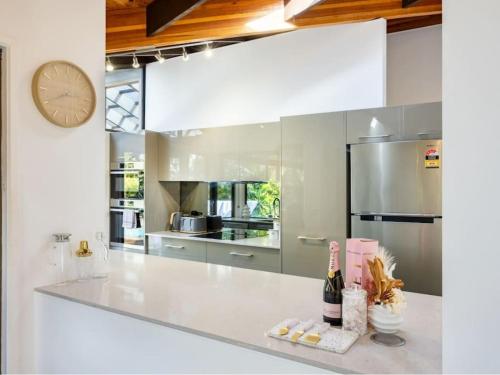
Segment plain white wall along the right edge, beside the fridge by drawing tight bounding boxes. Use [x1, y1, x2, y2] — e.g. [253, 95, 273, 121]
[443, 0, 500, 373]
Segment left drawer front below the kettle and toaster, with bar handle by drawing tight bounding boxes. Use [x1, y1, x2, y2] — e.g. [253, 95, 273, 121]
[148, 236, 207, 262]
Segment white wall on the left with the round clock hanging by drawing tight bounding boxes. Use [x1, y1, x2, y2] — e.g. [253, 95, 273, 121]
[0, 0, 107, 372]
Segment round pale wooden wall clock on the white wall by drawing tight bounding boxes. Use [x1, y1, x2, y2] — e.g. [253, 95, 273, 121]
[32, 61, 96, 128]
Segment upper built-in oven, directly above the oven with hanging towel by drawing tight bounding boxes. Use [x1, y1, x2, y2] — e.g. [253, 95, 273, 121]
[110, 162, 144, 203]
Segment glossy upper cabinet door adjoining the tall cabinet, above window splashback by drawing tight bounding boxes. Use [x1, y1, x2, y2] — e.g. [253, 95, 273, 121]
[236, 122, 281, 181]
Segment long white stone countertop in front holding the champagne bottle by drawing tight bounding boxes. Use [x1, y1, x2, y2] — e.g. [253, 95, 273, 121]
[36, 251, 441, 373]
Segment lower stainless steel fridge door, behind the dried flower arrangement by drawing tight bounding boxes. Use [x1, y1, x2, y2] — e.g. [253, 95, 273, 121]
[351, 215, 442, 296]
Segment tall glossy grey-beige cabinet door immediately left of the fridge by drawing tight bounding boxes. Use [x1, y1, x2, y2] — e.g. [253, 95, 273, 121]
[281, 113, 347, 278]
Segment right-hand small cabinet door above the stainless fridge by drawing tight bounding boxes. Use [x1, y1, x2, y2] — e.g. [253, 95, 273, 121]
[403, 102, 443, 140]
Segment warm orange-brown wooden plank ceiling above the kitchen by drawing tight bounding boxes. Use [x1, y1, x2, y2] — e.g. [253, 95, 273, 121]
[106, 0, 442, 53]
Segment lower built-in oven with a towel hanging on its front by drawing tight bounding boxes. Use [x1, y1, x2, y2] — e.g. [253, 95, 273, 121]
[109, 200, 145, 253]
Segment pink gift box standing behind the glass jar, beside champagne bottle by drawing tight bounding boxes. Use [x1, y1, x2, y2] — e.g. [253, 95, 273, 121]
[346, 238, 378, 292]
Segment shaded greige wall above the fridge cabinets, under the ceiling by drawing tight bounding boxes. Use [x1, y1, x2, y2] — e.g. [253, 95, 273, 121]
[387, 25, 442, 105]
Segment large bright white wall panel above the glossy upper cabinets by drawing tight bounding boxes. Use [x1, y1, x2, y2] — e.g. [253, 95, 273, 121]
[146, 20, 386, 131]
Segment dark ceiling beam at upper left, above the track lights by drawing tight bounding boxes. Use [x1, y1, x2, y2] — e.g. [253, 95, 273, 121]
[146, 0, 206, 36]
